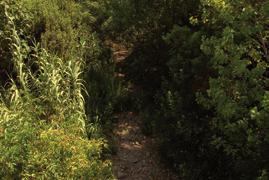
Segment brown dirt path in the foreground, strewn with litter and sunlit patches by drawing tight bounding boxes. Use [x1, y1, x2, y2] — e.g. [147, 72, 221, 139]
[113, 112, 178, 180]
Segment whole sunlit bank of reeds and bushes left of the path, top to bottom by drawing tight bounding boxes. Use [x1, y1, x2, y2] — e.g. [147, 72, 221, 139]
[0, 0, 113, 179]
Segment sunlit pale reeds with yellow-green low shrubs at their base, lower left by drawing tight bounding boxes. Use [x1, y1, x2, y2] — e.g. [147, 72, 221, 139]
[0, 3, 112, 179]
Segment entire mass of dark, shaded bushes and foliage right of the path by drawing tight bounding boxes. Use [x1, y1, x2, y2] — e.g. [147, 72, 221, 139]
[108, 0, 269, 179]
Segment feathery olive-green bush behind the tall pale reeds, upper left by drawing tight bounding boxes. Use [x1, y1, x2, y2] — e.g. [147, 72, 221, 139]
[23, 0, 87, 59]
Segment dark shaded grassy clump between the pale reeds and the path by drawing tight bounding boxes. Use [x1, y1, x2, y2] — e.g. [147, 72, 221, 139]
[85, 47, 121, 130]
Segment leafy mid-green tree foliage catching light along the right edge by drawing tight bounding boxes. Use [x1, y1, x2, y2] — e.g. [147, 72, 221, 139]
[198, 0, 269, 179]
